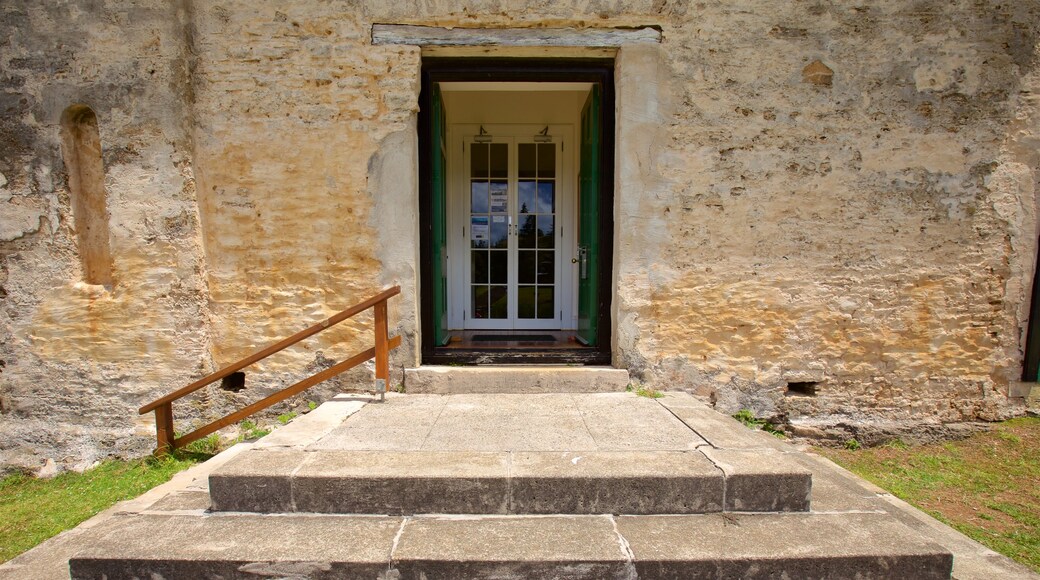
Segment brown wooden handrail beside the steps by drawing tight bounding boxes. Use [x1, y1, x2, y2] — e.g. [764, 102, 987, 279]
[138, 286, 400, 454]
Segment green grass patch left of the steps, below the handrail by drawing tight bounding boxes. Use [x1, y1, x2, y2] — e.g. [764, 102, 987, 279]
[0, 453, 210, 562]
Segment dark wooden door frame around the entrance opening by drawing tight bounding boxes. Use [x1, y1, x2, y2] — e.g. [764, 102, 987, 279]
[417, 57, 615, 365]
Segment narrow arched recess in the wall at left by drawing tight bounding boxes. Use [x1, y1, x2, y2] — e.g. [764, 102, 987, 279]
[61, 105, 112, 287]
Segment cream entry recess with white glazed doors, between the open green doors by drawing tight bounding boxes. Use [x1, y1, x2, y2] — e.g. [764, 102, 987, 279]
[441, 83, 591, 331]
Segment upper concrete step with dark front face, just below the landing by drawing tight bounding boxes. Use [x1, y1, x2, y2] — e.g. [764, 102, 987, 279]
[209, 447, 812, 515]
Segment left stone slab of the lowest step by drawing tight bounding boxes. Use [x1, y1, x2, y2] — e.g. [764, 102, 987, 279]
[69, 515, 401, 580]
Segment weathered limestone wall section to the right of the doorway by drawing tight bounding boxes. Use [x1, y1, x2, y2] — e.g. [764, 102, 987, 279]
[616, 2, 1040, 439]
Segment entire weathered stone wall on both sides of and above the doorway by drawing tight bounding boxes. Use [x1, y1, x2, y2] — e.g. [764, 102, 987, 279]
[0, 0, 1040, 473]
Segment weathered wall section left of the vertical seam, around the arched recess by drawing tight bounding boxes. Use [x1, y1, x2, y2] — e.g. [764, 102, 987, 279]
[0, 0, 209, 468]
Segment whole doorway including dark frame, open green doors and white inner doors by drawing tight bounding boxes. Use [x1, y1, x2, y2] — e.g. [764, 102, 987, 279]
[419, 57, 614, 364]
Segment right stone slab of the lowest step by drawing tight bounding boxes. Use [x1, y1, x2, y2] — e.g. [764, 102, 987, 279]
[618, 513, 953, 579]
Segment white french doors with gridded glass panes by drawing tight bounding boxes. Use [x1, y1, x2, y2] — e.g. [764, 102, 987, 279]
[451, 126, 573, 329]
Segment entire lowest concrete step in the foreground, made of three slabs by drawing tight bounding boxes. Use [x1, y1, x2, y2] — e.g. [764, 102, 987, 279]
[69, 511, 953, 580]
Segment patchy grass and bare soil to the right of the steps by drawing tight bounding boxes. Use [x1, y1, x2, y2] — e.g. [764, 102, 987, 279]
[817, 418, 1040, 572]
